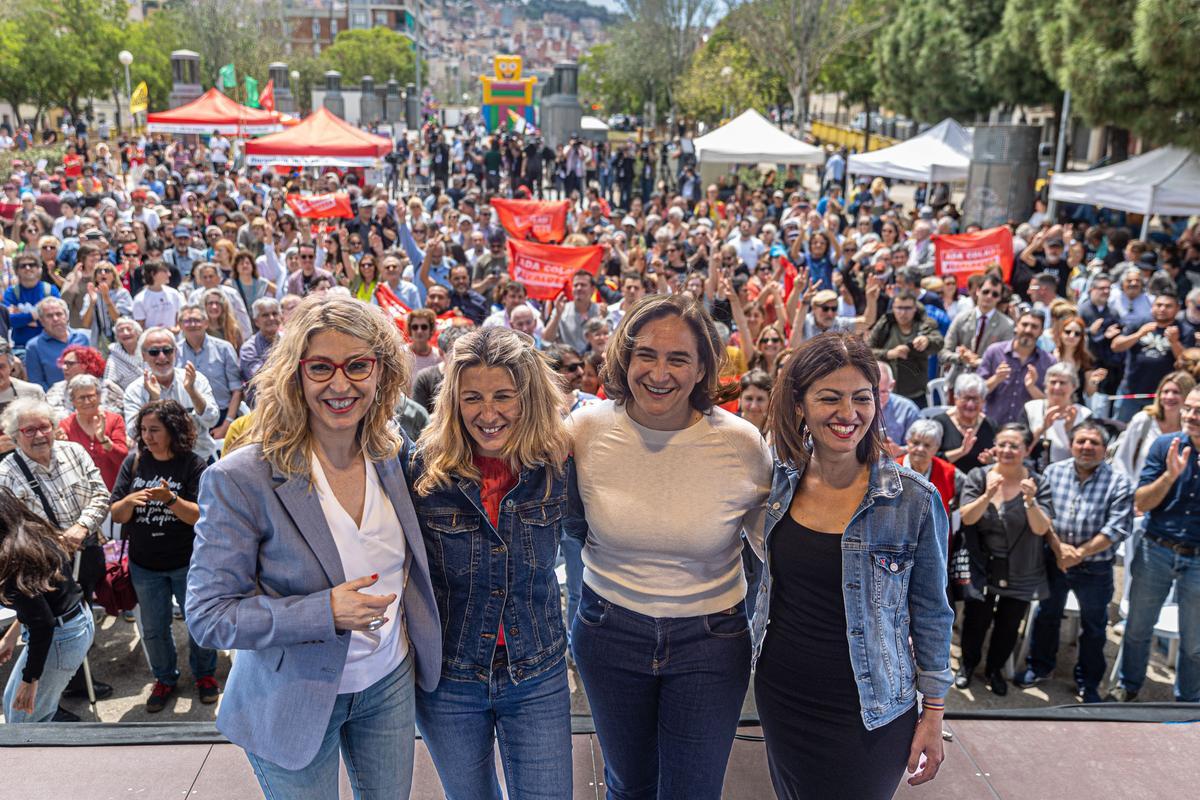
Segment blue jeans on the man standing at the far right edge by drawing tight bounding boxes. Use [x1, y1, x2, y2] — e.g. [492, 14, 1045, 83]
[1121, 536, 1200, 703]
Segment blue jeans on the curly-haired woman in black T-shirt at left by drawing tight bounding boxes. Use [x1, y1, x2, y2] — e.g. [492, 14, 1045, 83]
[130, 561, 217, 686]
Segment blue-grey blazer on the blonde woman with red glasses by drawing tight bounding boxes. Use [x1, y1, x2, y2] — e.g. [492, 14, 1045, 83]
[186, 444, 442, 770]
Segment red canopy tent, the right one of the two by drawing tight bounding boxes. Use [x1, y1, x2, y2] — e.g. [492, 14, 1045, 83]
[246, 108, 391, 167]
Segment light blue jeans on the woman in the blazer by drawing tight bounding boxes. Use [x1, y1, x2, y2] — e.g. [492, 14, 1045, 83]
[246, 651, 416, 800]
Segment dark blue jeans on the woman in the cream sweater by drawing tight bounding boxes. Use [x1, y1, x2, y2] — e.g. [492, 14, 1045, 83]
[572, 584, 750, 800]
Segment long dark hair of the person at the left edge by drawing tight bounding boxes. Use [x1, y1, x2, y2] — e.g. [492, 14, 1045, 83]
[0, 488, 66, 603]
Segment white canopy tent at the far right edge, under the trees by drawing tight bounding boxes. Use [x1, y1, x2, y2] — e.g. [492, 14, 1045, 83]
[1050, 148, 1200, 239]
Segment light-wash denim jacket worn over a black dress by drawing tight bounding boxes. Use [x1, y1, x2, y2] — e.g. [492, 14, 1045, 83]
[751, 457, 954, 730]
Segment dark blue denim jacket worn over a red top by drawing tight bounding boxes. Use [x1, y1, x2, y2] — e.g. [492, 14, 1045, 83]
[407, 451, 566, 684]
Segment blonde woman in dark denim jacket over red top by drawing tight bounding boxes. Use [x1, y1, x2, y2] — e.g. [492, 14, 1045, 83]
[409, 327, 571, 800]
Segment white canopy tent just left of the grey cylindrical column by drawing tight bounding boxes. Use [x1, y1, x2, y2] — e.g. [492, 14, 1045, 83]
[846, 118, 971, 182]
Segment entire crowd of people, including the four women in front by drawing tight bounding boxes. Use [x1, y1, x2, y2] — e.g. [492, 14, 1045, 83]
[0, 113, 1200, 798]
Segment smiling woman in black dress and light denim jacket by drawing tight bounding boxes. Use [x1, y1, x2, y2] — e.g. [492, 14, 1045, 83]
[752, 333, 954, 800]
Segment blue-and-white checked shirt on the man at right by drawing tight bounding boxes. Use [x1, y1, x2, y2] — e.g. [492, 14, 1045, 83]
[1043, 458, 1133, 561]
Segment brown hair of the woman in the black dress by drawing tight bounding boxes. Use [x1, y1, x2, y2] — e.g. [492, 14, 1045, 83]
[767, 332, 883, 468]
